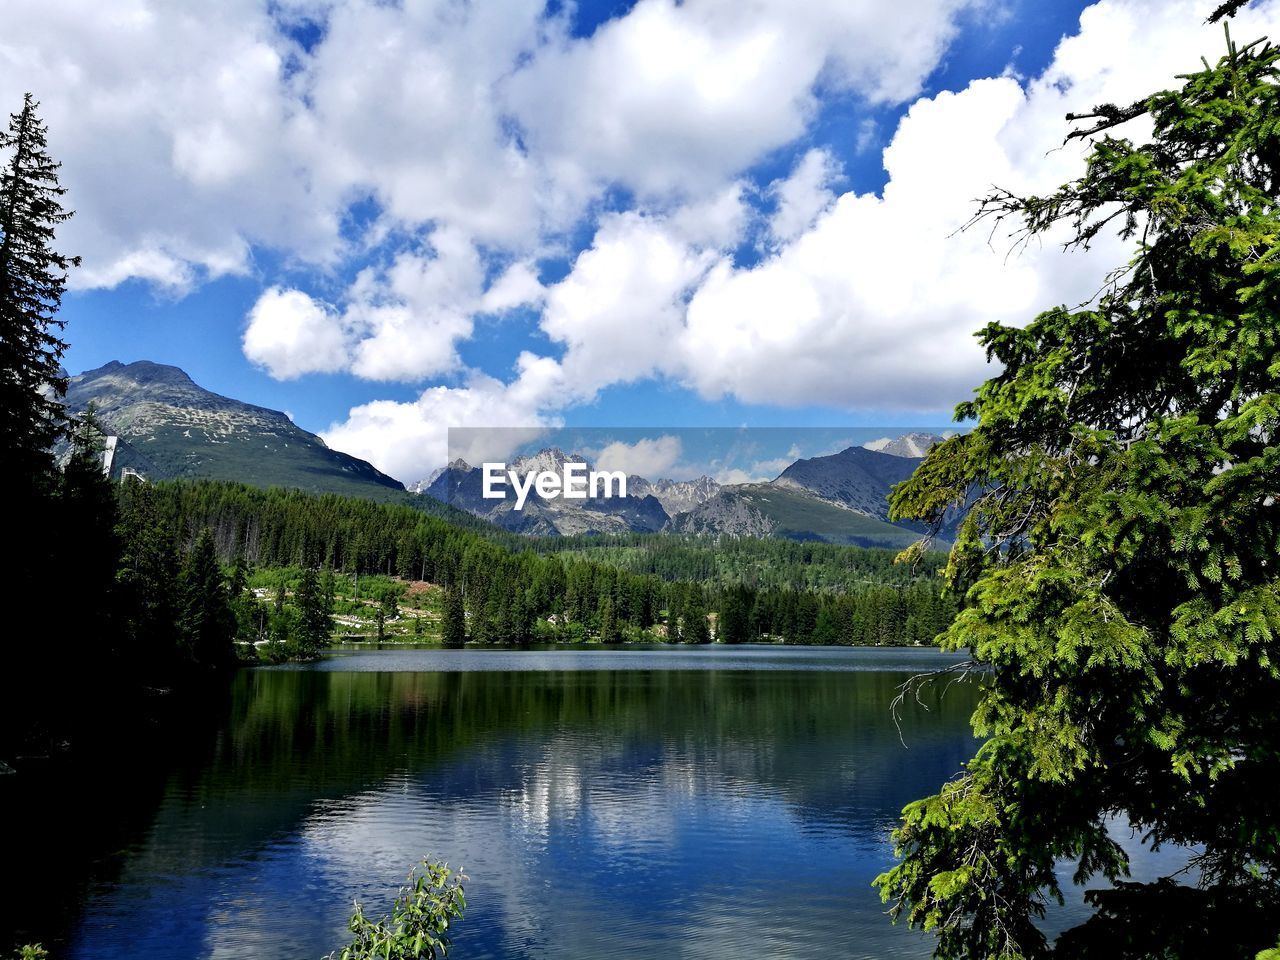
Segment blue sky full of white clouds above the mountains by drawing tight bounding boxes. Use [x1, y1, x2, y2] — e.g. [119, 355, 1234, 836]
[0, 0, 1280, 483]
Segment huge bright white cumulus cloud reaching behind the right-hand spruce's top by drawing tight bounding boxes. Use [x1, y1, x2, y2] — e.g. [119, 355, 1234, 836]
[325, 0, 1280, 480]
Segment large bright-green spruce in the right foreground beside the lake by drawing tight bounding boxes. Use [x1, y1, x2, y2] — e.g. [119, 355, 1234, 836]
[879, 18, 1280, 960]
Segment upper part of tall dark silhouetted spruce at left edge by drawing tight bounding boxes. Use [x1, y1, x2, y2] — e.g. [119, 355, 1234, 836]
[0, 93, 79, 509]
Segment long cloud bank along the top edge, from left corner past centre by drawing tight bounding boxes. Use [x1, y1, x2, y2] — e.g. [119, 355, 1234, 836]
[0, 0, 980, 293]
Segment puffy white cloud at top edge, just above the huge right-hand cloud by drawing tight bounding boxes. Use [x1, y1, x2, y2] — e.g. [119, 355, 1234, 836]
[506, 0, 982, 197]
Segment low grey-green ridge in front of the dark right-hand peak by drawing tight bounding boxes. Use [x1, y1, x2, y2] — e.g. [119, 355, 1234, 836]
[668, 481, 919, 549]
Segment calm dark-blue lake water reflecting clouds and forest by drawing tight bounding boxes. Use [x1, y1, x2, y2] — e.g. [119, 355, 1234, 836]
[0, 648, 1172, 960]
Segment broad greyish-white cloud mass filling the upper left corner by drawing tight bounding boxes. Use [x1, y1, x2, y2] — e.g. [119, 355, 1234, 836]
[0, 0, 548, 293]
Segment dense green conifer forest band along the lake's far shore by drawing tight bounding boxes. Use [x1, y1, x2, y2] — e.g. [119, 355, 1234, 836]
[145, 481, 955, 644]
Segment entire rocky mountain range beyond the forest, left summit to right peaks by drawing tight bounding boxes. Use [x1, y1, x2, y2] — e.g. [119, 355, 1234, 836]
[67, 361, 941, 548]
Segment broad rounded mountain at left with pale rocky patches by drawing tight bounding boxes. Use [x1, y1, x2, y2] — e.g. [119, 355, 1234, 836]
[67, 360, 404, 498]
